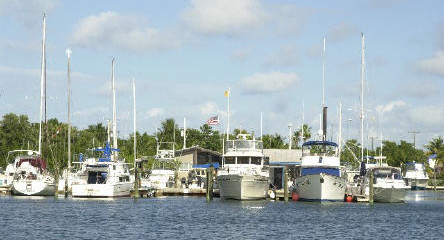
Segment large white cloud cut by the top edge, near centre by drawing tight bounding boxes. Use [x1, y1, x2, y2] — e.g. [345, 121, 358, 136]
[182, 0, 268, 36]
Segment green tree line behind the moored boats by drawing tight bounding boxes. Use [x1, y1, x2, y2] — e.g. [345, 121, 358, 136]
[0, 113, 444, 174]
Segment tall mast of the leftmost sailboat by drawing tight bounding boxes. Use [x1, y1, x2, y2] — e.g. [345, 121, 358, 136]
[39, 14, 46, 155]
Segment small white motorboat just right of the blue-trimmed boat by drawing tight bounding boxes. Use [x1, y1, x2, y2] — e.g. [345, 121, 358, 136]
[362, 166, 409, 203]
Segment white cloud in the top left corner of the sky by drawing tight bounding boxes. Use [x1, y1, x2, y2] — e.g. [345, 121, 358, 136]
[0, 0, 59, 28]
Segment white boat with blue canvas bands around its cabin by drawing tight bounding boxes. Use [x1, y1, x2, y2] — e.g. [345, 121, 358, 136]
[295, 141, 346, 201]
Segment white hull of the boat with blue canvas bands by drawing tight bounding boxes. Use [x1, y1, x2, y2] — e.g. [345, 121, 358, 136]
[296, 174, 346, 201]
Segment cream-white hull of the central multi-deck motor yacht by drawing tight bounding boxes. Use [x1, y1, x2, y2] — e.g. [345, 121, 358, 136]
[217, 174, 269, 200]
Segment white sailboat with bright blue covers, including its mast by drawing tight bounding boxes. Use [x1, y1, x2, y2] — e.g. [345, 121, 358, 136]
[71, 59, 134, 197]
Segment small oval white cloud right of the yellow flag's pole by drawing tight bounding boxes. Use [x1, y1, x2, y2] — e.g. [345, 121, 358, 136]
[240, 72, 299, 93]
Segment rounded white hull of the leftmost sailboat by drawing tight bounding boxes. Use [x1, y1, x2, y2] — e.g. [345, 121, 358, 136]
[12, 179, 56, 196]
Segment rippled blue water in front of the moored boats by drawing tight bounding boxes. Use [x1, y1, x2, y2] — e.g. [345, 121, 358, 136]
[0, 191, 444, 239]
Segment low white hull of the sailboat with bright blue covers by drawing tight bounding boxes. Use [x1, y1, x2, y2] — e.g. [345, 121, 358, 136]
[71, 182, 134, 197]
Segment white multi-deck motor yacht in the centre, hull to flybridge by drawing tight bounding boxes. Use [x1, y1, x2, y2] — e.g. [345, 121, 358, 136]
[217, 134, 269, 200]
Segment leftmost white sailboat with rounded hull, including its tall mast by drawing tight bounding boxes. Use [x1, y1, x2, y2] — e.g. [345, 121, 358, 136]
[7, 15, 56, 196]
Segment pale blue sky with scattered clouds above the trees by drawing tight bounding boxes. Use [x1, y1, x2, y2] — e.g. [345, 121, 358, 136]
[0, 0, 444, 148]
